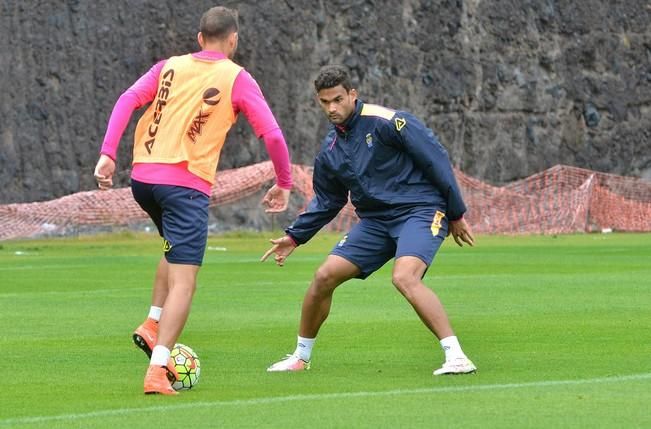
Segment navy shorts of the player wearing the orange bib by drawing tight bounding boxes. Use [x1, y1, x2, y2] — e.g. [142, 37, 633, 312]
[131, 179, 208, 265]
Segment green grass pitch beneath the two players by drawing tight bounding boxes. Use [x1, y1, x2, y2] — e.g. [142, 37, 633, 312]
[0, 234, 651, 428]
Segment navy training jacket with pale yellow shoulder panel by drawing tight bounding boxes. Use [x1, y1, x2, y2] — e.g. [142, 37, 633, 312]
[285, 100, 466, 244]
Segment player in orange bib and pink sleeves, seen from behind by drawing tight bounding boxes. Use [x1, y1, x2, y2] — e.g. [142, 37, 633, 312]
[95, 7, 292, 395]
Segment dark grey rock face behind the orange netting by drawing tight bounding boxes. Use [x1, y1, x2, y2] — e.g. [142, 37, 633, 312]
[0, 0, 651, 203]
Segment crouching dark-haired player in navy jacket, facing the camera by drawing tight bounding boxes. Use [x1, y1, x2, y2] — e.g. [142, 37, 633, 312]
[262, 66, 476, 375]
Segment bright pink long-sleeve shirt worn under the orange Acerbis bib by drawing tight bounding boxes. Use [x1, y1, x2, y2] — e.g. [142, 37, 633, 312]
[101, 51, 292, 195]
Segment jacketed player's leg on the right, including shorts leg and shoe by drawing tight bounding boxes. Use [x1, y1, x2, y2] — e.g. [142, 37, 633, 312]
[392, 209, 477, 375]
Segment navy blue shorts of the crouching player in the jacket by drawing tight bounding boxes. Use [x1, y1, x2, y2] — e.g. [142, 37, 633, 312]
[330, 207, 448, 279]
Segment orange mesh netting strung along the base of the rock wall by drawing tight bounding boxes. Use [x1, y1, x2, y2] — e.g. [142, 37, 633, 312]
[0, 161, 651, 240]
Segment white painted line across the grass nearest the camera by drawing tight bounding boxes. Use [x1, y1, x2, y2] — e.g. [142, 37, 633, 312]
[0, 373, 651, 426]
